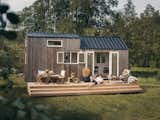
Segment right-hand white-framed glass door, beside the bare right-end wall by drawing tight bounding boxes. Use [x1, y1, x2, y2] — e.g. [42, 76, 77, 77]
[109, 52, 119, 76]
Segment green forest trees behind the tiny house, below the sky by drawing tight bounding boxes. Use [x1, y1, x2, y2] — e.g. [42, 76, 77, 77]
[0, 0, 160, 72]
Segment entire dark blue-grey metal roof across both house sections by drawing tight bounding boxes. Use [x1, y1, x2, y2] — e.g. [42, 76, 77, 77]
[27, 32, 128, 50]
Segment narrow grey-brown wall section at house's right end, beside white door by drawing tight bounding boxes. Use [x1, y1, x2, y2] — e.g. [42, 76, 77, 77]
[119, 50, 129, 75]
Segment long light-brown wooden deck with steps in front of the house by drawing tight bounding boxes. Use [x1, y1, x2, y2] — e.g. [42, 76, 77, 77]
[27, 82, 143, 96]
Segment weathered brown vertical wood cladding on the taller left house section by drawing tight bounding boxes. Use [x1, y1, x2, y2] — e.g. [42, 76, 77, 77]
[25, 38, 84, 82]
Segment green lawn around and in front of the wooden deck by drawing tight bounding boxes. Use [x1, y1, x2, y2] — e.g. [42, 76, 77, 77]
[0, 68, 160, 120]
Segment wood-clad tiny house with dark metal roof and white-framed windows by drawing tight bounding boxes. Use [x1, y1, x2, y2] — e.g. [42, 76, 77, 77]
[25, 32, 128, 82]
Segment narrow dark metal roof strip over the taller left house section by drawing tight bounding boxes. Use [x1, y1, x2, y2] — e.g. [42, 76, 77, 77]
[27, 32, 79, 38]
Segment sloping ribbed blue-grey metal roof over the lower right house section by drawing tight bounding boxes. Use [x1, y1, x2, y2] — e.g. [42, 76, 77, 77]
[80, 36, 128, 50]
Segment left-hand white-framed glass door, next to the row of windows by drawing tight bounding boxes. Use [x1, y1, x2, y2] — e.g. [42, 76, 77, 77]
[86, 52, 94, 74]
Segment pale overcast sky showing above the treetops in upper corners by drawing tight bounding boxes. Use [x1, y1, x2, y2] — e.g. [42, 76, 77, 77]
[1, 0, 160, 13]
